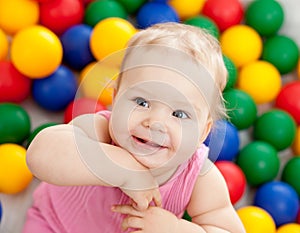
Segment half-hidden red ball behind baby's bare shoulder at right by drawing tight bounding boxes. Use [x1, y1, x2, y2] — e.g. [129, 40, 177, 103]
[215, 161, 247, 204]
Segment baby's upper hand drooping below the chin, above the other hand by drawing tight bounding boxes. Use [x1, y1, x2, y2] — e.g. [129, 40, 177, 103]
[122, 188, 161, 211]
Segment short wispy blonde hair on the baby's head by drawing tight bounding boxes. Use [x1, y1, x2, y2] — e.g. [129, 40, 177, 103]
[118, 23, 227, 120]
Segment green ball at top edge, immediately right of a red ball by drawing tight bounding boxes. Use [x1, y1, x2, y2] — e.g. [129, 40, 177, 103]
[245, 0, 284, 36]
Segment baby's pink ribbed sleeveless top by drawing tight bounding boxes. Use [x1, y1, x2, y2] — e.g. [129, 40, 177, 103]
[24, 111, 208, 233]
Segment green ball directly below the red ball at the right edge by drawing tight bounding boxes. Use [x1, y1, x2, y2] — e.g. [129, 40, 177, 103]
[253, 109, 296, 151]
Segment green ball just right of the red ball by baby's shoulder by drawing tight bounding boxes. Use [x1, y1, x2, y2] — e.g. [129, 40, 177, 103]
[236, 141, 280, 186]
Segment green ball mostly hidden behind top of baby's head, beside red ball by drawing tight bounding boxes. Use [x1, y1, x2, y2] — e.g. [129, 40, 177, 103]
[183, 15, 220, 39]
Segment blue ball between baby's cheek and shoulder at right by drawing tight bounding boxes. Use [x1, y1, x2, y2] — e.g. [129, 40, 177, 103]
[204, 120, 240, 161]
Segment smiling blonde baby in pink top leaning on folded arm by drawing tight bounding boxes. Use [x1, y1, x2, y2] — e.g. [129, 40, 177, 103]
[23, 23, 245, 233]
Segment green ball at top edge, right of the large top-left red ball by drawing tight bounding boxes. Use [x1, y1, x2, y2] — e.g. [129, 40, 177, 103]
[84, 0, 128, 27]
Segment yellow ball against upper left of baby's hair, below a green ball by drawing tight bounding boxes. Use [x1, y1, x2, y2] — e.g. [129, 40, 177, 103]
[90, 17, 137, 60]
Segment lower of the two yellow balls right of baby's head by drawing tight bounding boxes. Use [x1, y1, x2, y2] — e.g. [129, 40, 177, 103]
[237, 60, 281, 104]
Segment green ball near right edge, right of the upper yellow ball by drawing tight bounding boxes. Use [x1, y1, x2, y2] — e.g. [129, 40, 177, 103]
[262, 35, 299, 74]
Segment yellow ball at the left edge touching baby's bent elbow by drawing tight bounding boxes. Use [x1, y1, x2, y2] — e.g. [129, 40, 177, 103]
[0, 143, 33, 194]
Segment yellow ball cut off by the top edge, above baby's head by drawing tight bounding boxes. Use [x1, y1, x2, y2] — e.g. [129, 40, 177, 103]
[169, 0, 205, 19]
